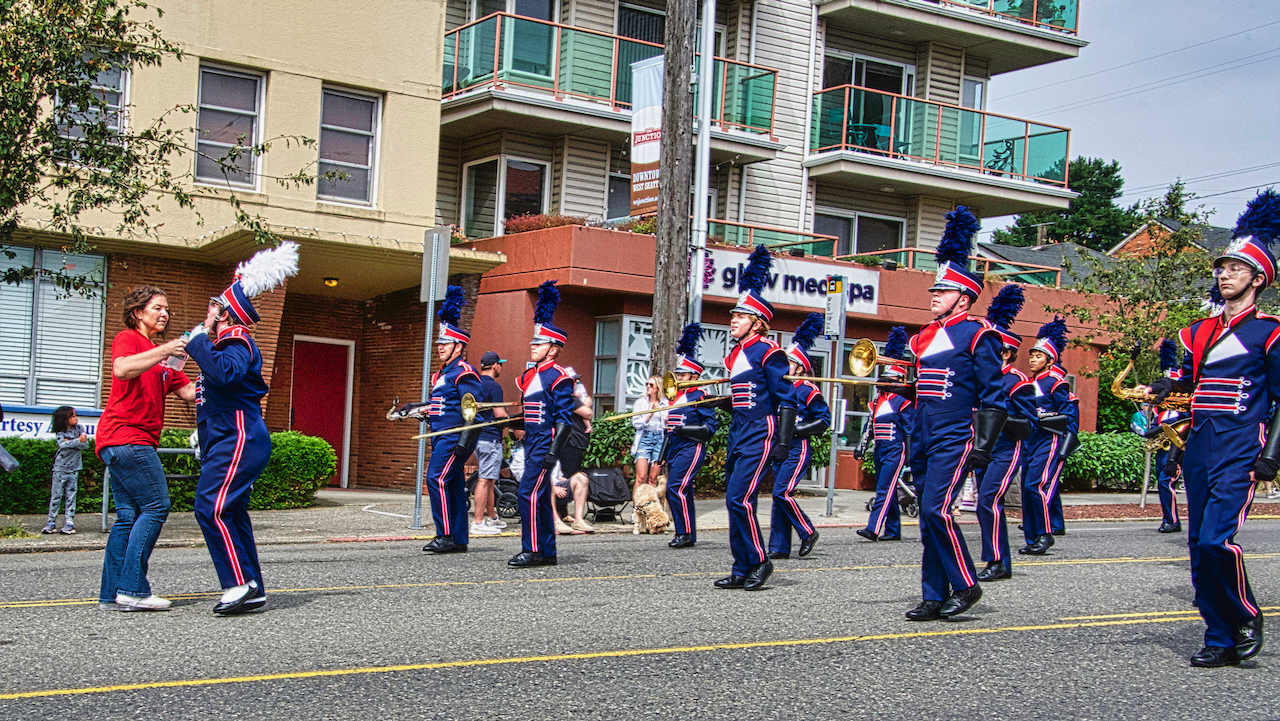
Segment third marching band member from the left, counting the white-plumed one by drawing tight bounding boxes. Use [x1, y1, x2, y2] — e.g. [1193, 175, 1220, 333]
[507, 280, 573, 567]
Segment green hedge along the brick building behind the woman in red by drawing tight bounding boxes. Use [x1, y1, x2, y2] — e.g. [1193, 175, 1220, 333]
[0, 428, 338, 514]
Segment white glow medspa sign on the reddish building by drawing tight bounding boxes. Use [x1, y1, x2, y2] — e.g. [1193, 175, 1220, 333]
[703, 248, 879, 315]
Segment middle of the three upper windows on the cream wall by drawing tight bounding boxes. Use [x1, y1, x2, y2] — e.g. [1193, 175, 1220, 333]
[196, 68, 262, 187]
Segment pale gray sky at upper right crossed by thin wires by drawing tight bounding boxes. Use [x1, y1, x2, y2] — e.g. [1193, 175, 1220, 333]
[979, 0, 1280, 235]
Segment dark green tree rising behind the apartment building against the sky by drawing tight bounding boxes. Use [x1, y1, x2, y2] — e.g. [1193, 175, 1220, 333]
[995, 156, 1143, 252]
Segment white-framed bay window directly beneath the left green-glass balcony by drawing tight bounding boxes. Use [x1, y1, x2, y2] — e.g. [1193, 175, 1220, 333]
[462, 155, 550, 238]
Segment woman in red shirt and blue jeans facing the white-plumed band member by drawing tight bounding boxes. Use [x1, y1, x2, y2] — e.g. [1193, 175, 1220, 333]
[96, 286, 196, 611]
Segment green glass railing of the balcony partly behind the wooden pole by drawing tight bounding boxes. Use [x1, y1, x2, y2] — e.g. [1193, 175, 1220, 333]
[443, 13, 778, 134]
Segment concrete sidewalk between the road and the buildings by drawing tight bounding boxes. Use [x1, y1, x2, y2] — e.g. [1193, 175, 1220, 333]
[0, 488, 1280, 553]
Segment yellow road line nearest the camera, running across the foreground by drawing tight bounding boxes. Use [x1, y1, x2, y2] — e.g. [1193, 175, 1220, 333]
[0, 616, 1274, 701]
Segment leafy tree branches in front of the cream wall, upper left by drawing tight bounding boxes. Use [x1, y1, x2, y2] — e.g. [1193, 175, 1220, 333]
[0, 0, 330, 295]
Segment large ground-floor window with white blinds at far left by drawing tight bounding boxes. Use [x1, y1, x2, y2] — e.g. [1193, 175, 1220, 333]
[0, 246, 106, 409]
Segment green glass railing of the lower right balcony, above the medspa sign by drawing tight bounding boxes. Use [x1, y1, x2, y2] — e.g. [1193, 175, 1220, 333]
[812, 85, 1071, 188]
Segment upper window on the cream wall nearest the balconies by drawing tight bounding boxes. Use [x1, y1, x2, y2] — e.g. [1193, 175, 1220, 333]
[316, 90, 378, 204]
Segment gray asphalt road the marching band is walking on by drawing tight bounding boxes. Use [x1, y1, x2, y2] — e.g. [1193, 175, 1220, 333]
[0, 520, 1280, 720]
